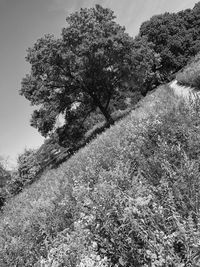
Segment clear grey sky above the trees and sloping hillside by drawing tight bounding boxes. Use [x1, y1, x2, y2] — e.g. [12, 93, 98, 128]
[0, 0, 198, 168]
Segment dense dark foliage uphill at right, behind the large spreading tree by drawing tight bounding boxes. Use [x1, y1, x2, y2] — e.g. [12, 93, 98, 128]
[139, 3, 200, 80]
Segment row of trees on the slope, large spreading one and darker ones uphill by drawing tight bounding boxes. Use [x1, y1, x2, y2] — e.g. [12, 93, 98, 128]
[20, 3, 200, 157]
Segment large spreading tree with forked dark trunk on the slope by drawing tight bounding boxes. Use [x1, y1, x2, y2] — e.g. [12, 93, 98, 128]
[20, 5, 133, 144]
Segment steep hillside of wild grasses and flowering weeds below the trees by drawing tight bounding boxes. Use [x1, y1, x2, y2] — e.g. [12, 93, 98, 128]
[0, 86, 200, 266]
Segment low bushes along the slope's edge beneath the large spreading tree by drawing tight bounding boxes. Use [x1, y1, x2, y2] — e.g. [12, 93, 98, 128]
[3, 104, 141, 201]
